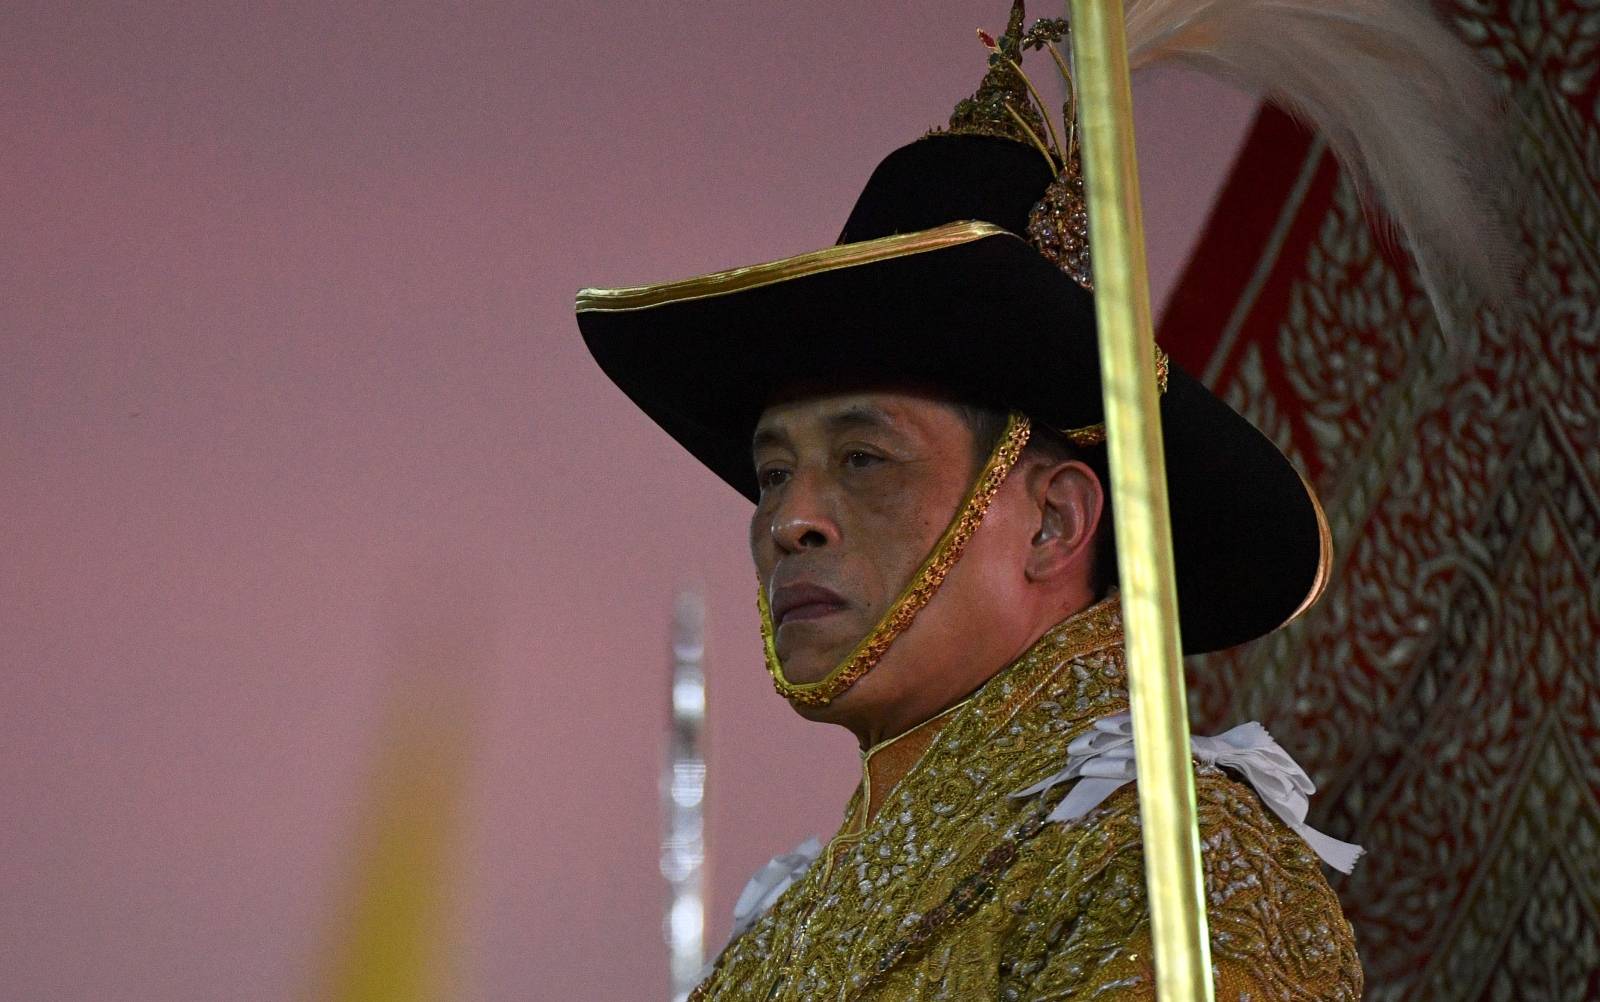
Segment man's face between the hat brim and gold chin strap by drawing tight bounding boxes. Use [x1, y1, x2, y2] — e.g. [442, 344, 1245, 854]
[750, 385, 976, 682]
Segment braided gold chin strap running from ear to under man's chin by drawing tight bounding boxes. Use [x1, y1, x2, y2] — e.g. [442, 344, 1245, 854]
[755, 411, 1029, 706]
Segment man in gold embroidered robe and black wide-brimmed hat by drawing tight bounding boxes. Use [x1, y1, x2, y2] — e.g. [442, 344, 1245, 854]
[578, 10, 1362, 1002]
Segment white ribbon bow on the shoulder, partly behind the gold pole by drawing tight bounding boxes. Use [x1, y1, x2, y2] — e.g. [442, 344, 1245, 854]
[1011, 714, 1365, 874]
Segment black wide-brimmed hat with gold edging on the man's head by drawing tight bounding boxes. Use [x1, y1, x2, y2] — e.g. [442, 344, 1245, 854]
[578, 134, 1331, 653]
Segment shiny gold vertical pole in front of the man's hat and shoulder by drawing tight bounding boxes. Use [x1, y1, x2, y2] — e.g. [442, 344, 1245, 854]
[1067, 0, 1211, 1002]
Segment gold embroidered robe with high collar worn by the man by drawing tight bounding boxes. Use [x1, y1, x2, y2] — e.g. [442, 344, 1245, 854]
[691, 599, 1362, 1002]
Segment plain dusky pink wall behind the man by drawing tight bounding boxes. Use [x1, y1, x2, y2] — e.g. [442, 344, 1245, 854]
[0, 0, 1253, 1002]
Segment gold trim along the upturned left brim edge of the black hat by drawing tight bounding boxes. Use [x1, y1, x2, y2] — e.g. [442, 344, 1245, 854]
[578, 221, 1021, 314]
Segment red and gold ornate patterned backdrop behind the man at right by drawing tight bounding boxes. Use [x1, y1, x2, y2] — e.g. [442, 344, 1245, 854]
[1162, 0, 1600, 1002]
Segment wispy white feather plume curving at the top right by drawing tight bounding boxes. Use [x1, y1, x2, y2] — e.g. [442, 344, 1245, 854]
[1126, 0, 1515, 312]
